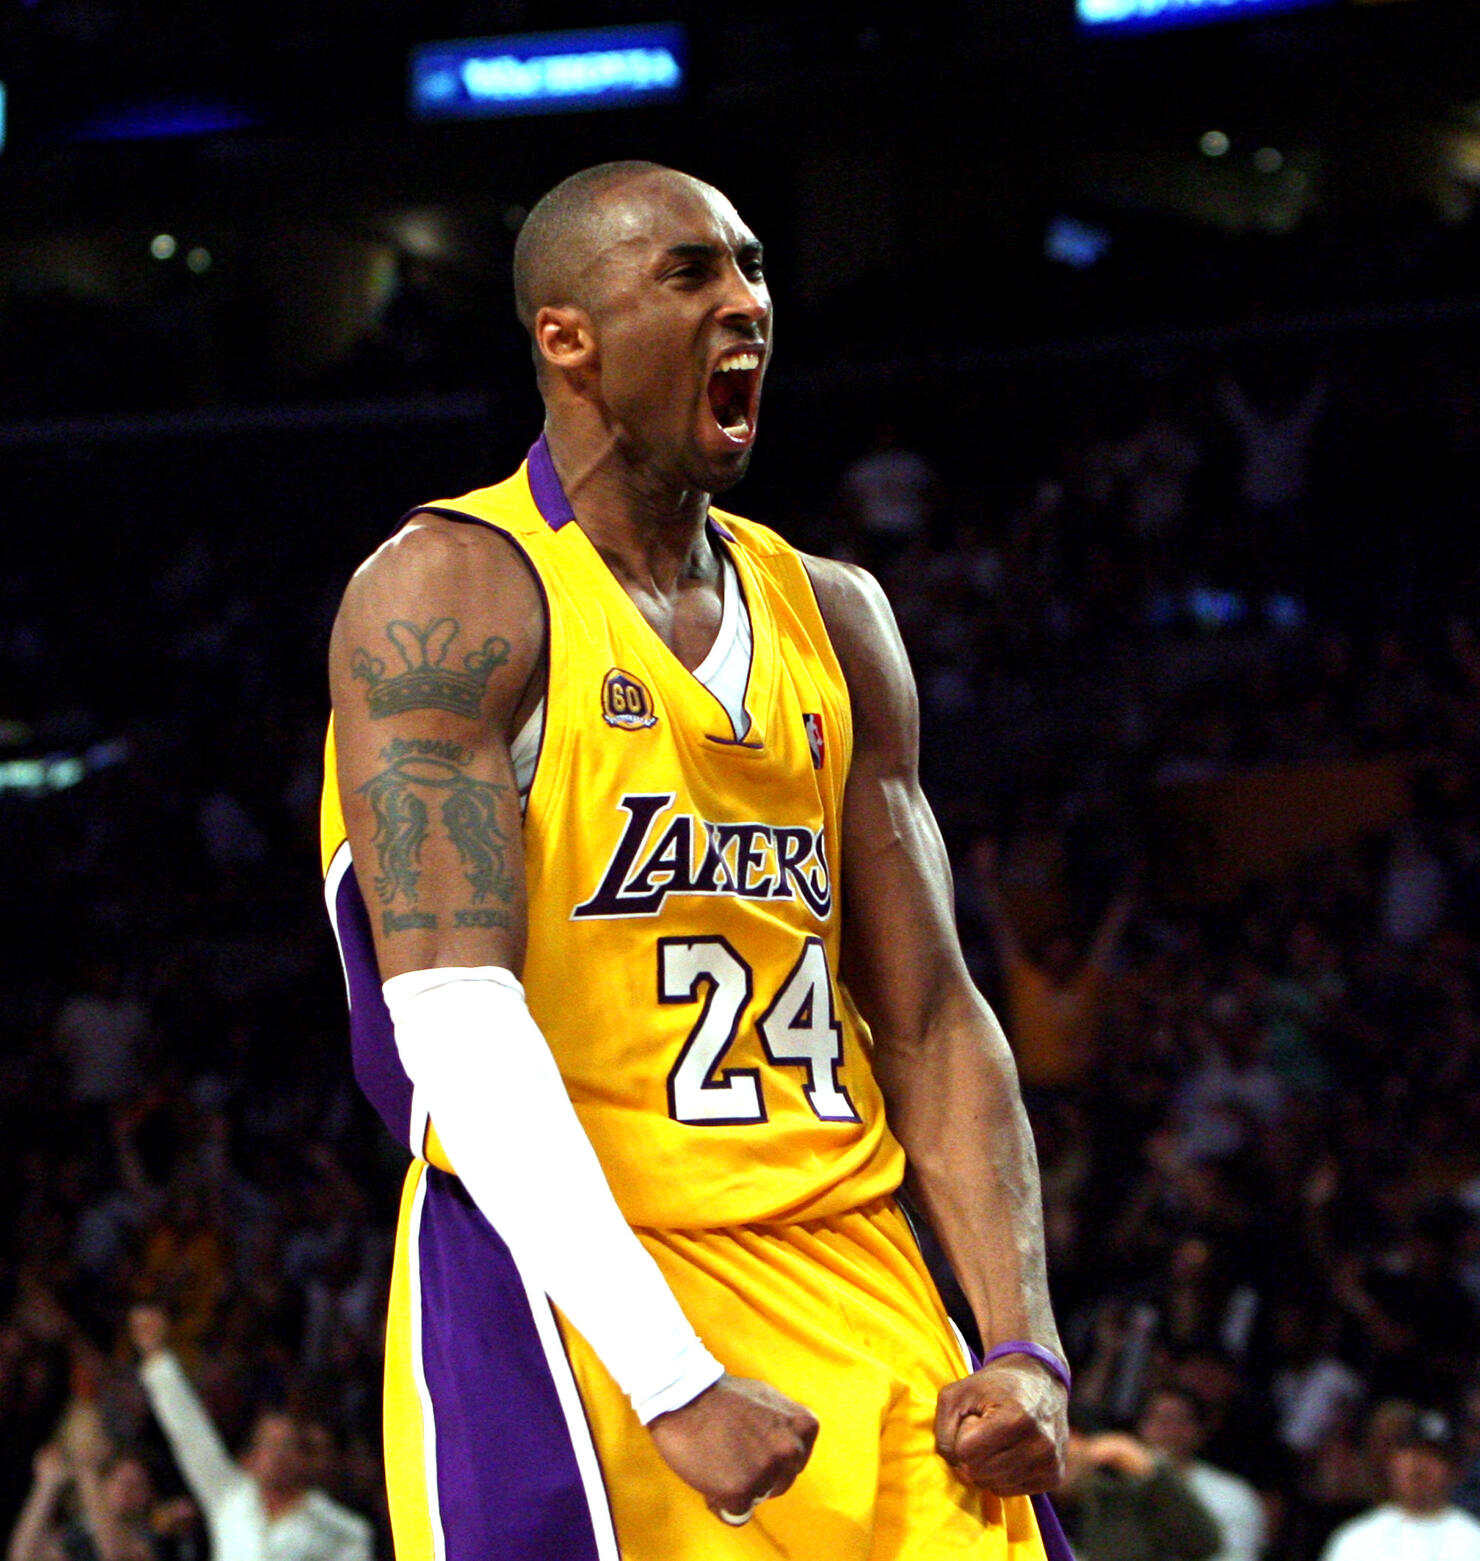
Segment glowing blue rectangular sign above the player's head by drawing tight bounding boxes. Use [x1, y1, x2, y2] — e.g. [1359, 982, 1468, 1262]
[411, 23, 685, 119]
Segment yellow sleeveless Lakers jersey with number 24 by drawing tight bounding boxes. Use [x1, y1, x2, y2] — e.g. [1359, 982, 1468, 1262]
[325, 440, 904, 1230]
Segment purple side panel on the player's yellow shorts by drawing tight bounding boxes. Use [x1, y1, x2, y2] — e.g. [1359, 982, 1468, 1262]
[417, 1166, 598, 1561]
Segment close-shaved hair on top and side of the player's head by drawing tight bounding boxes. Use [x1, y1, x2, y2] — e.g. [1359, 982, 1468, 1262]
[514, 159, 703, 334]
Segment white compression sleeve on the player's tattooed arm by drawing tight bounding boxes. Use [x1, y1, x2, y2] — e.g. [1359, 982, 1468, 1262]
[384, 965, 724, 1425]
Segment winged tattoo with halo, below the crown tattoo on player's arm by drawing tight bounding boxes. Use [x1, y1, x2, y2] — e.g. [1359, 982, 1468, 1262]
[359, 737, 515, 911]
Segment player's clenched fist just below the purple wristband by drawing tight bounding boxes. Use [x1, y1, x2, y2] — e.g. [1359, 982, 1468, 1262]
[935, 1358, 1069, 1495]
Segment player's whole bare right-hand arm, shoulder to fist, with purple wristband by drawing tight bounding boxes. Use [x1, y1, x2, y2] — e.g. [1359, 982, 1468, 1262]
[807, 559, 1068, 1495]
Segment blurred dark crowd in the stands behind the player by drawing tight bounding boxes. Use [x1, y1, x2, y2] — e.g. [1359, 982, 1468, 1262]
[0, 323, 1480, 1561]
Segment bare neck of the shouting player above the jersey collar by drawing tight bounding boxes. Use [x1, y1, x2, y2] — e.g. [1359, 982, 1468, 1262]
[545, 417, 713, 592]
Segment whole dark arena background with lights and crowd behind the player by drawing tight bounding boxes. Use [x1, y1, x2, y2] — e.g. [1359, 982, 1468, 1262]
[0, 0, 1480, 1561]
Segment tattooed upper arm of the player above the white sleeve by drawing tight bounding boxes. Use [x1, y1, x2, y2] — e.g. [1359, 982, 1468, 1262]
[329, 517, 545, 979]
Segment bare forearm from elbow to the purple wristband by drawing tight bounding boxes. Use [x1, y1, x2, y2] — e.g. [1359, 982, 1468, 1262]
[876, 990, 1062, 1353]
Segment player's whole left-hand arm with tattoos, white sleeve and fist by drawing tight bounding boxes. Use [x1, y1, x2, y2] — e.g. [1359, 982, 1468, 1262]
[329, 515, 816, 1513]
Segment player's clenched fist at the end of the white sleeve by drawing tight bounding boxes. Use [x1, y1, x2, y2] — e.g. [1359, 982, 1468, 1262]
[648, 1374, 816, 1522]
